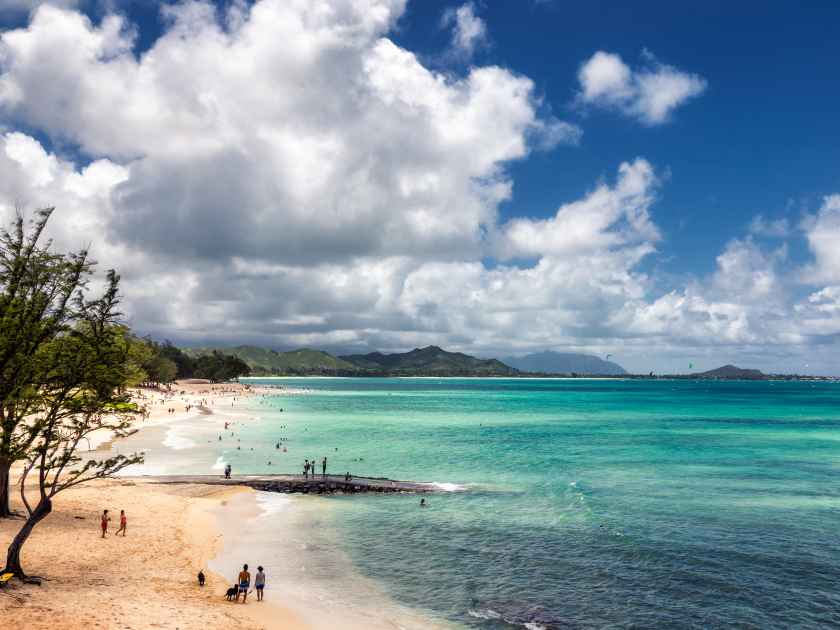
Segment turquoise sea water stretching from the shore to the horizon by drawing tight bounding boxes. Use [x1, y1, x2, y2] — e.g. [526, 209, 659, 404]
[228, 379, 840, 628]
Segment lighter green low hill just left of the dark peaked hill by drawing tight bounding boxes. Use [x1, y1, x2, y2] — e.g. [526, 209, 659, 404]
[184, 346, 356, 375]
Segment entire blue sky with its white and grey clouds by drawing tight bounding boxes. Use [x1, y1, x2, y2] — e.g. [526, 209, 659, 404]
[0, 0, 840, 374]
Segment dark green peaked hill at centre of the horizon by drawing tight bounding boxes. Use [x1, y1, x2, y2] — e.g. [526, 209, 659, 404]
[339, 346, 517, 376]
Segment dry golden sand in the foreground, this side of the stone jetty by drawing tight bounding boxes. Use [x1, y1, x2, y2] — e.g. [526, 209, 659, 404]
[0, 480, 308, 630]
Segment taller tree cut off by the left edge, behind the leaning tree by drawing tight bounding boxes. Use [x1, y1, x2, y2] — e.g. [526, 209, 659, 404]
[0, 208, 91, 517]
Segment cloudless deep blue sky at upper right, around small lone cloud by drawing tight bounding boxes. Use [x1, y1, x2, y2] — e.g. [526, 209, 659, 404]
[395, 1, 840, 272]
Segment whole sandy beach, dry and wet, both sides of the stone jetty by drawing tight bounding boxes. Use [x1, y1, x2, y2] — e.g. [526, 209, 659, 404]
[0, 381, 450, 630]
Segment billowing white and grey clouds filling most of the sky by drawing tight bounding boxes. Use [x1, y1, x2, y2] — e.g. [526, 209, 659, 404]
[0, 0, 840, 376]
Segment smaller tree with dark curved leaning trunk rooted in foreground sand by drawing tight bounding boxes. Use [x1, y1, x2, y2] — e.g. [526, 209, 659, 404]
[5, 271, 142, 581]
